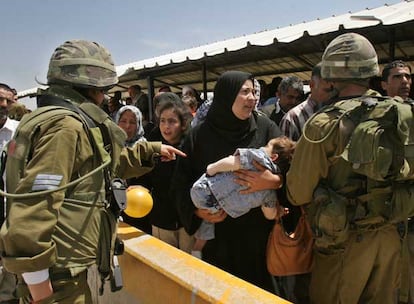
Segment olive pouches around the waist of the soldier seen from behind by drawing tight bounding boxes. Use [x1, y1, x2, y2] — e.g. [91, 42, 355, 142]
[311, 185, 396, 251]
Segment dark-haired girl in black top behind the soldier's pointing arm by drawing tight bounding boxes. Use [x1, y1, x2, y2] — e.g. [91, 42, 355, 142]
[139, 92, 194, 253]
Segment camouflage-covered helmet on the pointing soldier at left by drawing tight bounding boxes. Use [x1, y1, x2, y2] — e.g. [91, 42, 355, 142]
[47, 40, 118, 89]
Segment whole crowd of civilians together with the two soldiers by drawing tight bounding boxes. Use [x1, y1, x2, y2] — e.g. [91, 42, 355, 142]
[0, 33, 414, 304]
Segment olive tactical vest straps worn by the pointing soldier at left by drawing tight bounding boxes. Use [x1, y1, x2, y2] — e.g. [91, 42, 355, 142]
[6, 97, 126, 290]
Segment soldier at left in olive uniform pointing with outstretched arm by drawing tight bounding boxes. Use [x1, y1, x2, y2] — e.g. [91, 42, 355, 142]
[0, 40, 182, 303]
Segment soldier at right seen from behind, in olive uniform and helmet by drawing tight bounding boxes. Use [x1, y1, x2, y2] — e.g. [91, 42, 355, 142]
[287, 33, 413, 304]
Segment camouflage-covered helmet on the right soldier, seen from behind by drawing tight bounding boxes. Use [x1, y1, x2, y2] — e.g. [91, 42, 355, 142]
[321, 33, 379, 80]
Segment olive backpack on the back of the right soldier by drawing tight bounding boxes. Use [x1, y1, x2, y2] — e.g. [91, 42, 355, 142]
[310, 95, 414, 216]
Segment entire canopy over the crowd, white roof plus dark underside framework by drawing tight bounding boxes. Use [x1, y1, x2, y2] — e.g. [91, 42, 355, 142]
[111, 1, 414, 95]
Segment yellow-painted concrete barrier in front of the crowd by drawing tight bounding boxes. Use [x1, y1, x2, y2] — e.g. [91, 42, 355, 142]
[99, 225, 290, 304]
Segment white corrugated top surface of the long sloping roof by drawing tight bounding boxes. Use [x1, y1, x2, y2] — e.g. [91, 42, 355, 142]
[117, 1, 414, 82]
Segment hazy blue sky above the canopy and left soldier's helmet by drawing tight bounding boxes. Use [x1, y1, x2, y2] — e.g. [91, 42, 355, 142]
[0, 0, 401, 91]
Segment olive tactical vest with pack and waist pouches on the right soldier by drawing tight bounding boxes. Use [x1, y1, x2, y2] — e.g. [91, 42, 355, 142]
[304, 96, 414, 248]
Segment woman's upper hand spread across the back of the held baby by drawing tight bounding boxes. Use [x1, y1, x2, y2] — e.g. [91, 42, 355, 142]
[234, 161, 283, 194]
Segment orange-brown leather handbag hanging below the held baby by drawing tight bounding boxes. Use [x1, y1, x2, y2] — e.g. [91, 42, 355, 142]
[266, 209, 313, 276]
